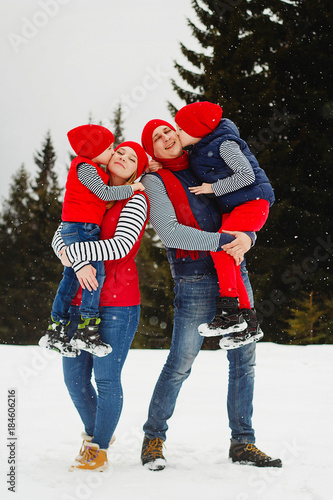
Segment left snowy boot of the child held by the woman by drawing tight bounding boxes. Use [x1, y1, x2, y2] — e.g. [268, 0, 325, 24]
[38, 316, 80, 358]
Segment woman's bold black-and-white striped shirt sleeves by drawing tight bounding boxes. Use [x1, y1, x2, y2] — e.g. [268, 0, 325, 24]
[52, 195, 148, 272]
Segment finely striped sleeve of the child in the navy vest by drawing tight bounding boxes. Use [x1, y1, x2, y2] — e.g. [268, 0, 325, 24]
[212, 141, 255, 196]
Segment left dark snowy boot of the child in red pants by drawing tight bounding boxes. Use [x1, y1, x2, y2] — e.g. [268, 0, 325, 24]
[198, 297, 247, 337]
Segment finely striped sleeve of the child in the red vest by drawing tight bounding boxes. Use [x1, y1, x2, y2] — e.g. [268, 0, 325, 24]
[77, 163, 134, 201]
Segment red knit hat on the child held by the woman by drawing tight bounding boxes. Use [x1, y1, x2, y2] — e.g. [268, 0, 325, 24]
[67, 124, 114, 160]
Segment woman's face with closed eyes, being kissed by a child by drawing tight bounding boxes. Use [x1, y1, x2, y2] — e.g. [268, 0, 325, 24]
[108, 146, 138, 186]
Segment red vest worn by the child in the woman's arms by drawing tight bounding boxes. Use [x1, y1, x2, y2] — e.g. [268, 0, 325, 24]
[61, 156, 109, 226]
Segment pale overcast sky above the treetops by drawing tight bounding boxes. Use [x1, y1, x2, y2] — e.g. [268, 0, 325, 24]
[0, 0, 198, 201]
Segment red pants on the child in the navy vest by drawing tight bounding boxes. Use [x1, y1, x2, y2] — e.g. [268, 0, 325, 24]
[211, 199, 269, 309]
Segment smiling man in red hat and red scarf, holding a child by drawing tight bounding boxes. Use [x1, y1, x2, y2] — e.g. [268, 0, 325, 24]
[137, 120, 282, 470]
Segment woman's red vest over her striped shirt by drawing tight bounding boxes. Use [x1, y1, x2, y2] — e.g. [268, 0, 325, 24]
[72, 192, 149, 307]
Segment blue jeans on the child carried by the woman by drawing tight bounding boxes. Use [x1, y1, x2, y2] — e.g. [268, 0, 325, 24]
[51, 222, 105, 323]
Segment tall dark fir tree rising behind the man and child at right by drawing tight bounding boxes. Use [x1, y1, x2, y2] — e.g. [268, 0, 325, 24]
[170, 0, 333, 341]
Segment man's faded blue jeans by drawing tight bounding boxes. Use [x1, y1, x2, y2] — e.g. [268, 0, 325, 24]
[143, 267, 256, 443]
